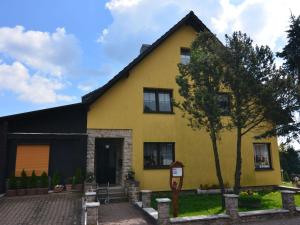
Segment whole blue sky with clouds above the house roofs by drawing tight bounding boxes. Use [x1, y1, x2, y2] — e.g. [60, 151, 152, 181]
[0, 0, 300, 116]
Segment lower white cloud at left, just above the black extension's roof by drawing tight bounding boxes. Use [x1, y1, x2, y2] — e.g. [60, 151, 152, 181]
[0, 62, 74, 104]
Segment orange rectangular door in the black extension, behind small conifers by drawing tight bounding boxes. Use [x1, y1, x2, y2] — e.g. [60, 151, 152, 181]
[15, 145, 50, 176]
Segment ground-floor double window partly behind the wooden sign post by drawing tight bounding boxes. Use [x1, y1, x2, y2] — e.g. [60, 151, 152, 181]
[144, 142, 175, 169]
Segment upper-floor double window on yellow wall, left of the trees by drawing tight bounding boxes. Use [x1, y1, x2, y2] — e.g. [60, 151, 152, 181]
[144, 88, 173, 113]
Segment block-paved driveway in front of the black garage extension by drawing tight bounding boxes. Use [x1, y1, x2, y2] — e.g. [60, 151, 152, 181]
[0, 193, 81, 225]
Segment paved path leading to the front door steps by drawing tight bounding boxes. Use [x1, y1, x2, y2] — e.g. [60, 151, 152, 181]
[99, 202, 153, 225]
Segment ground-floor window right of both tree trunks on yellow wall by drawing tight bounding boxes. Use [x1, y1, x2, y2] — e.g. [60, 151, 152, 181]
[253, 143, 272, 170]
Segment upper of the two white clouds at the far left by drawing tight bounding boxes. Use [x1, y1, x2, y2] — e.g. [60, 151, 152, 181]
[0, 26, 80, 76]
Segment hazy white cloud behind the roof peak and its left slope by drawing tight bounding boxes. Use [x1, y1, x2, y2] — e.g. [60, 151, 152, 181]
[98, 0, 220, 64]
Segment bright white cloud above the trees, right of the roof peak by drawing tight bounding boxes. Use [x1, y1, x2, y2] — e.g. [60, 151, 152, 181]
[212, 0, 300, 51]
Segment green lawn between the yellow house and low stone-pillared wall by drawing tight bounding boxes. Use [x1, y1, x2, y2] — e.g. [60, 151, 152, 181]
[151, 191, 300, 217]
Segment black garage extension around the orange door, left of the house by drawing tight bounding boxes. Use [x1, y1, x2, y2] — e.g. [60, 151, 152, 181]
[0, 104, 87, 193]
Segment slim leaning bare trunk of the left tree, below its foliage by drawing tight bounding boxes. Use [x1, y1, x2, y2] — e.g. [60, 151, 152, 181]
[210, 131, 225, 209]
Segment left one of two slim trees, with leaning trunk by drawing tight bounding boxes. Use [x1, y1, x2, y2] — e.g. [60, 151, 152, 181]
[175, 31, 226, 207]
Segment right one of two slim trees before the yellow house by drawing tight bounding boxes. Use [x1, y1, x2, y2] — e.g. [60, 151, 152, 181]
[223, 32, 289, 194]
